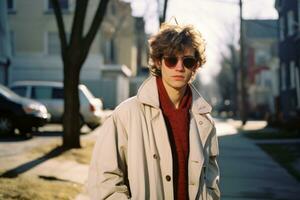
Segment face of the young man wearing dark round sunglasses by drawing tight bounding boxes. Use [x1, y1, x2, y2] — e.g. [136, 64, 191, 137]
[161, 48, 196, 90]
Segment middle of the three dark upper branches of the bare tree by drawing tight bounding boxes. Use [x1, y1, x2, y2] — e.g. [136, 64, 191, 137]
[70, 0, 89, 45]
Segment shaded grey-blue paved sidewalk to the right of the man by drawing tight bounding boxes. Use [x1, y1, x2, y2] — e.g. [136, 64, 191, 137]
[219, 119, 300, 200]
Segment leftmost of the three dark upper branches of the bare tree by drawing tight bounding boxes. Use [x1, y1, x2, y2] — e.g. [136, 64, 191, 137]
[51, 0, 68, 55]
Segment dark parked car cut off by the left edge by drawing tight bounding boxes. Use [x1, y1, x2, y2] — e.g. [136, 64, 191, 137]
[0, 84, 50, 134]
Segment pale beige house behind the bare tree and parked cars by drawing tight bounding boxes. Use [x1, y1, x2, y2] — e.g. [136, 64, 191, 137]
[7, 0, 145, 108]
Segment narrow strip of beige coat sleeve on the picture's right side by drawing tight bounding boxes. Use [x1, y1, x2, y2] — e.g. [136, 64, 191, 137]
[206, 127, 220, 200]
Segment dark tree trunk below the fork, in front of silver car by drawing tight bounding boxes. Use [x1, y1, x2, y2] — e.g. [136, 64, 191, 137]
[63, 57, 81, 149]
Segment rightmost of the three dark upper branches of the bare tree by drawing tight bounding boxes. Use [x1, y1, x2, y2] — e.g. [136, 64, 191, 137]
[84, 0, 109, 54]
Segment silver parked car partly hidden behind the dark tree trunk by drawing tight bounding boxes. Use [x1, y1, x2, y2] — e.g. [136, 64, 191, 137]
[10, 81, 103, 129]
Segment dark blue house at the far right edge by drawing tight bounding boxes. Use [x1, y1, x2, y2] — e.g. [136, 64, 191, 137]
[275, 0, 300, 119]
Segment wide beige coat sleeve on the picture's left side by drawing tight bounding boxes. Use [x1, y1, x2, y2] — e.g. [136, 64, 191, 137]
[87, 114, 130, 200]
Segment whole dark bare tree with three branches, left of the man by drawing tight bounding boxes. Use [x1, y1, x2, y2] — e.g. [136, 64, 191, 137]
[51, 0, 109, 148]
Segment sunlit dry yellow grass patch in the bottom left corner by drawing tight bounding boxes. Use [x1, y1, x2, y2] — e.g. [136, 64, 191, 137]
[0, 175, 82, 200]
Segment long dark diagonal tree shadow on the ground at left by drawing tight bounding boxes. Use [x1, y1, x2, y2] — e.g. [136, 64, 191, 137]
[0, 146, 68, 178]
